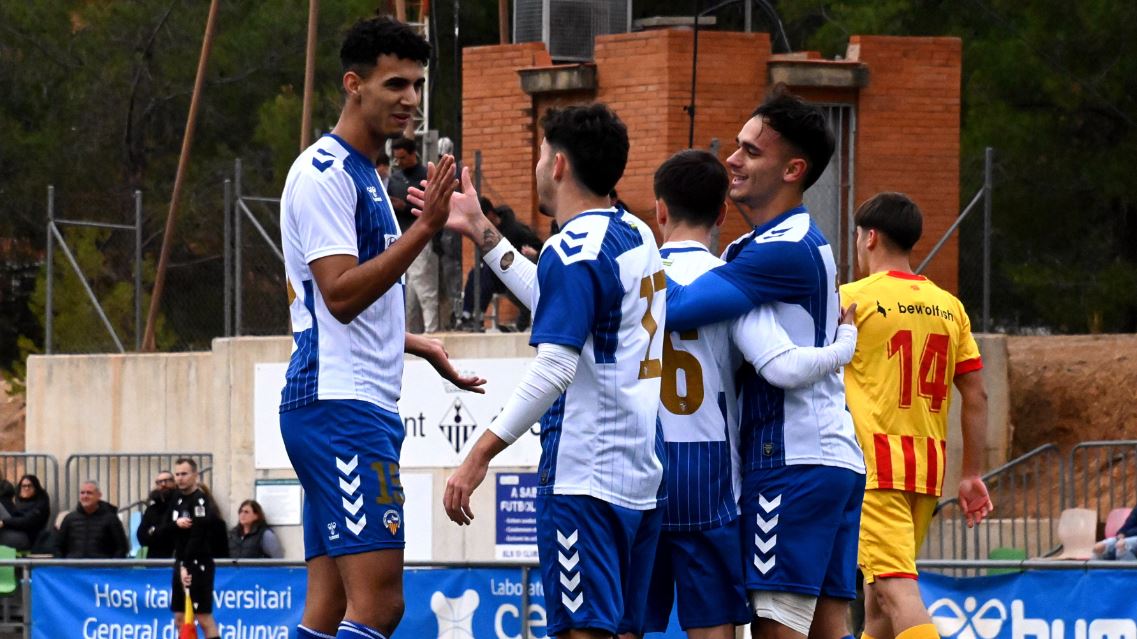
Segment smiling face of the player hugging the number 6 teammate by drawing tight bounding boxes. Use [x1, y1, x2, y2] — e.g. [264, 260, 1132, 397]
[727, 117, 789, 209]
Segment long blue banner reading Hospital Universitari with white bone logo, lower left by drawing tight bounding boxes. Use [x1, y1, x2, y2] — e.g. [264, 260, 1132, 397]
[31, 567, 682, 639]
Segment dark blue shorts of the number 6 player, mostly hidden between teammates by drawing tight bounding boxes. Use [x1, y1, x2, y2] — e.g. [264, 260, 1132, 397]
[644, 520, 750, 632]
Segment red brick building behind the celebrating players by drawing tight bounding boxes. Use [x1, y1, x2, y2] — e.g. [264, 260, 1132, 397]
[462, 28, 962, 313]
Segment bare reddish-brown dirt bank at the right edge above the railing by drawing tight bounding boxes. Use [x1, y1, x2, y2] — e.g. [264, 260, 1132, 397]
[1007, 335, 1137, 455]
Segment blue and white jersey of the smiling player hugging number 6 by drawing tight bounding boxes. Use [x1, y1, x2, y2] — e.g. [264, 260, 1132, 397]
[714, 206, 864, 473]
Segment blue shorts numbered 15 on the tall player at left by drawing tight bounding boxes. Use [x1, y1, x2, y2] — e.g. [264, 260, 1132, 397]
[281, 399, 406, 561]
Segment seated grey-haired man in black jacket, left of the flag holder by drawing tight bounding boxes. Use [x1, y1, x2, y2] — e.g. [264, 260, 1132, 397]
[56, 481, 131, 559]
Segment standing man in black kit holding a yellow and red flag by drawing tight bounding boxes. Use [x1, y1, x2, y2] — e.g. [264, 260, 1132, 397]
[159, 457, 229, 639]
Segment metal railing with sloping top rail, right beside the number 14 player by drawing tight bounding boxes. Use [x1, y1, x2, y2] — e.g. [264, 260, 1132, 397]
[921, 443, 1065, 561]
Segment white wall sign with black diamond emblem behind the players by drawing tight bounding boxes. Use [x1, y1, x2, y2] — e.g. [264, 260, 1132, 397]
[254, 358, 541, 470]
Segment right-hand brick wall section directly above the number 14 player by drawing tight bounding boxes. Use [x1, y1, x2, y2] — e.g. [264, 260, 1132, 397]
[849, 35, 962, 292]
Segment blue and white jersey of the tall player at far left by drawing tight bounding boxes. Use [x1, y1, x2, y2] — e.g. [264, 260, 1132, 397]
[281, 134, 405, 412]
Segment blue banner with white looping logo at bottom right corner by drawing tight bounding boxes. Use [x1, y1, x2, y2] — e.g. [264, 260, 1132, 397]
[920, 570, 1137, 639]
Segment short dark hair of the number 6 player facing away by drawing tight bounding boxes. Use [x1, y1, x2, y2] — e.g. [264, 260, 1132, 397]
[653, 149, 730, 226]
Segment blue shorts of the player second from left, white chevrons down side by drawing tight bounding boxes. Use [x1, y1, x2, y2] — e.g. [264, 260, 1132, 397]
[537, 495, 663, 637]
